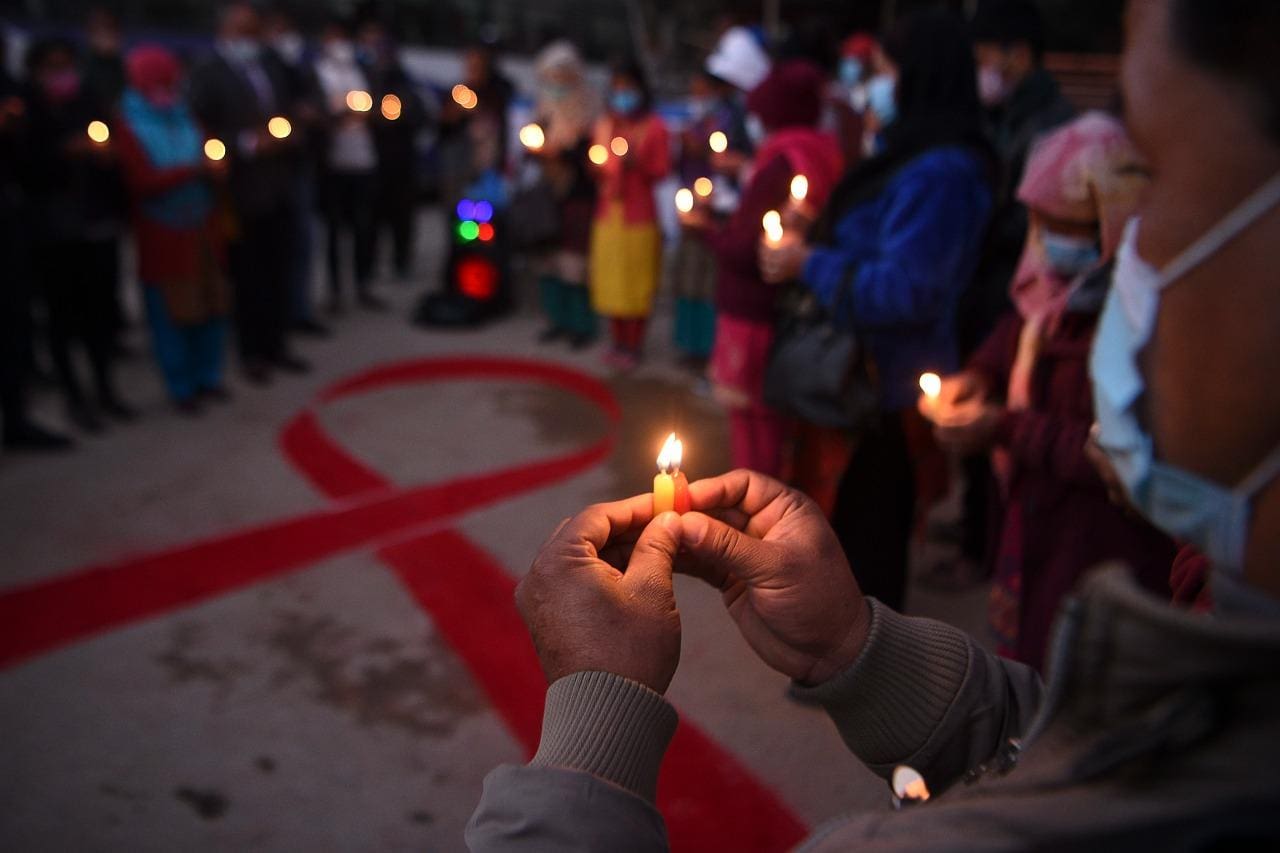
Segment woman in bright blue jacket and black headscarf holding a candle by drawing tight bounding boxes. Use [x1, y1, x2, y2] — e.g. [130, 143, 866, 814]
[760, 14, 996, 607]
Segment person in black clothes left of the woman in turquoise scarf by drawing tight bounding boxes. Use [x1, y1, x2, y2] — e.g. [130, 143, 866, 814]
[19, 40, 136, 433]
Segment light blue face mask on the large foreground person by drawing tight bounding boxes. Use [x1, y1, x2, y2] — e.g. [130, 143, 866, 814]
[1089, 174, 1280, 576]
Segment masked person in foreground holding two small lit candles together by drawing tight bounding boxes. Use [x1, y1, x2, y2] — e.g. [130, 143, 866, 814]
[467, 0, 1280, 852]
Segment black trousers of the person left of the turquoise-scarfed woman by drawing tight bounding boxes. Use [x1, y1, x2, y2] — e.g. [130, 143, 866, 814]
[35, 240, 119, 405]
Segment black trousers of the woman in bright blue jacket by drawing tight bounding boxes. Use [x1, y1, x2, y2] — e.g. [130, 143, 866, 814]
[831, 412, 915, 611]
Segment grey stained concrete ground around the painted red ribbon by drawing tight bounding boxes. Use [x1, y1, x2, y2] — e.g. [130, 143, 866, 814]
[0, 207, 983, 852]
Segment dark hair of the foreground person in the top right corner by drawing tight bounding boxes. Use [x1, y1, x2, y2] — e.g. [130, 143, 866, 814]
[1170, 0, 1280, 142]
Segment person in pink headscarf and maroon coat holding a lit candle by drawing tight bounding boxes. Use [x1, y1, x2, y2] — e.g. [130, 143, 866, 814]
[920, 113, 1175, 669]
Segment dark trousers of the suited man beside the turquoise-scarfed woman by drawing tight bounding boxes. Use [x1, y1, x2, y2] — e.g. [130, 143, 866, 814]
[228, 209, 294, 364]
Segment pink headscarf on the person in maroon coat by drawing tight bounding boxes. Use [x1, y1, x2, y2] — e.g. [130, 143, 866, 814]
[1009, 111, 1146, 324]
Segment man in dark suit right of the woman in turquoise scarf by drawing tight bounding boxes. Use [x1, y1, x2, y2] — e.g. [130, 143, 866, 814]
[192, 0, 308, 384]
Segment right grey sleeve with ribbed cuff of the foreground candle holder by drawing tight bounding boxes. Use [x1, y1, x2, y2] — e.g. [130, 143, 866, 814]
[794, 599, 1042, 793]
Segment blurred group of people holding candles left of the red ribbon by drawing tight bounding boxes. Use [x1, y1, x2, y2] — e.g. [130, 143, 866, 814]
[0, 3, 429, 438]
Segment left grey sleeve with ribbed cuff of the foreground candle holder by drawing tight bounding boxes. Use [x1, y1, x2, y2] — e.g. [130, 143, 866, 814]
[466, 672, 676, 853]
